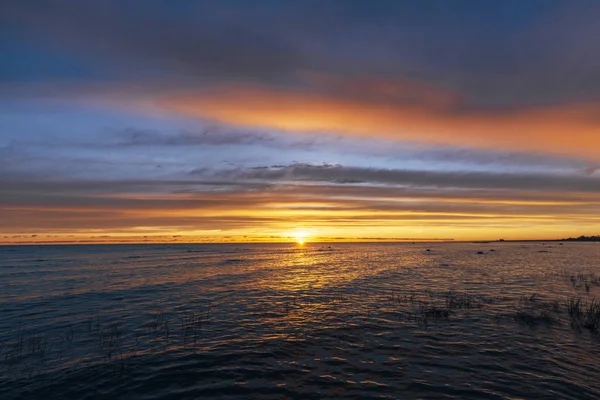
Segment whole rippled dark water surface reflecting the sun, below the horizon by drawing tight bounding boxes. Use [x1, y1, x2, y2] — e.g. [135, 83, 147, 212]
[0, 243, 600, 399]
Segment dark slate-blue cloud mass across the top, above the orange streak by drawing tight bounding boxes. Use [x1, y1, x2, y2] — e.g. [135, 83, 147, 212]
[2, 0, 600, 110]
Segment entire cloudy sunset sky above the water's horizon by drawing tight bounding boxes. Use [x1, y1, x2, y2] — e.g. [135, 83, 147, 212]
[0, 0, 600, 243]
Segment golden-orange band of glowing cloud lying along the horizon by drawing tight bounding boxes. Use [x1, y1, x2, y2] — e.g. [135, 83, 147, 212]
[0, 184, 600, 243]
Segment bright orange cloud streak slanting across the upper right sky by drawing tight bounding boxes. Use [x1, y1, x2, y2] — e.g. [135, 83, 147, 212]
[158, 81, 600, 160]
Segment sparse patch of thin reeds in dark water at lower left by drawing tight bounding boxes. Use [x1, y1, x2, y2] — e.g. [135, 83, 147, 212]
[0, 303, 212, 379]
